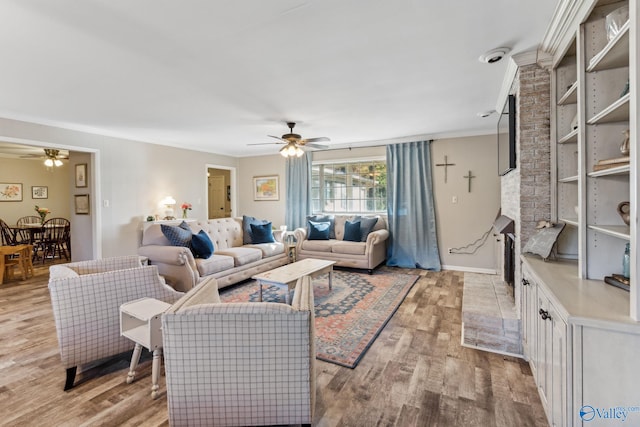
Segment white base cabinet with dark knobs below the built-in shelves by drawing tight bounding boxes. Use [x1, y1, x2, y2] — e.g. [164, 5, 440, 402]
[521, 256, 640, 426]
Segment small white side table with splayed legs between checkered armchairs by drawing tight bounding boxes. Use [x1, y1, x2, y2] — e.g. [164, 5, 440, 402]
[120, 298, 171, 399]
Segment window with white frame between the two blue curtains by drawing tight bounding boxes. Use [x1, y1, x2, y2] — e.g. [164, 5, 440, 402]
[311, 159, 387, 213]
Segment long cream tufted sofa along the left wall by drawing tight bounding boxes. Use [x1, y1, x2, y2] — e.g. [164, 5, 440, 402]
[138, 218, 289, 292]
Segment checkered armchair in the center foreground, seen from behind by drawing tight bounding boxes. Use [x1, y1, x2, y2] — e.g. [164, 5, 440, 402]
[162, 277, 315, 426]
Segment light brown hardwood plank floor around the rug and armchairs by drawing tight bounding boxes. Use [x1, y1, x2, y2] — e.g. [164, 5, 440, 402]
[0, 266, 547, 427]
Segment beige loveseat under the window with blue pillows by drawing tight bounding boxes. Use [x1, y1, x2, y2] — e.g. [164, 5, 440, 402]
[294, 215, 389, 273]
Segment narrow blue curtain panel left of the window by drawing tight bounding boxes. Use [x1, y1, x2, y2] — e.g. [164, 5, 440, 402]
[285, 153, 311, 230]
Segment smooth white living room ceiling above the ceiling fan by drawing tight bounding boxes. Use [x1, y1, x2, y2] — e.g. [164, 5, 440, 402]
[0, 0, 557, 156]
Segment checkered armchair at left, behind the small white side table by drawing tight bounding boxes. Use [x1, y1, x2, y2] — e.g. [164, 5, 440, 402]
[49, 256, 184, 390]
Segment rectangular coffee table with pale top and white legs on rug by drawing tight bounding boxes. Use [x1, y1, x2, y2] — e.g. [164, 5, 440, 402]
[252, 258, 336, 304]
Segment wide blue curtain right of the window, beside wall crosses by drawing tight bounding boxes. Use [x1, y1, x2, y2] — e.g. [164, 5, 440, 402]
[387, 141, 440, 271]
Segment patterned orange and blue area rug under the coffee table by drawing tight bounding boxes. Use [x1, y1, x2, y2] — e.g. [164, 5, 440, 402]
[220, 270, 419, 368]
